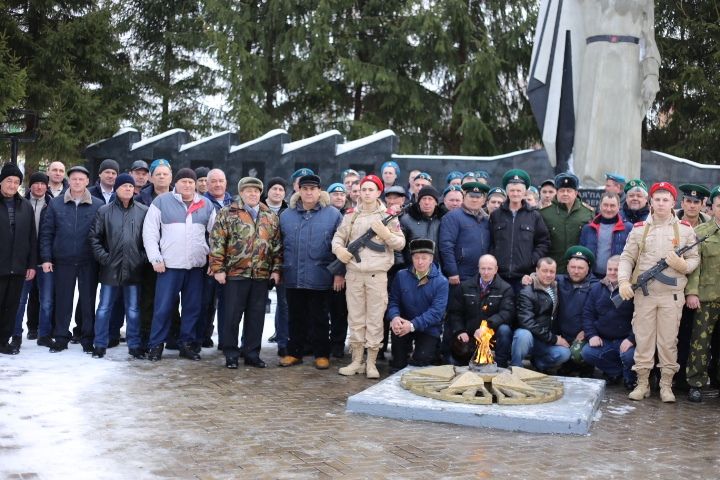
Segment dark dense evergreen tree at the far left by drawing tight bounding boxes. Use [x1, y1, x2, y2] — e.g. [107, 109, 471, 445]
[0, 0, 132, 171]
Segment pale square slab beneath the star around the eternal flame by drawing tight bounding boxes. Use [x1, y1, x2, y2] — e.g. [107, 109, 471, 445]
[346, 367, 605, 435]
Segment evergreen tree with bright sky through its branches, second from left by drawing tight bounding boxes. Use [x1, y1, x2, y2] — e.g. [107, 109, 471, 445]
[119, 0, 221, 135]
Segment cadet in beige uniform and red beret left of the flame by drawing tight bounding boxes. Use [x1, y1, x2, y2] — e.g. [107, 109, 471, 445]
[332, 175, 405, 378]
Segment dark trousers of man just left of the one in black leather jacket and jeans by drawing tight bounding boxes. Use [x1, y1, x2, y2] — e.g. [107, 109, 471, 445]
[53, 262, 98, 347]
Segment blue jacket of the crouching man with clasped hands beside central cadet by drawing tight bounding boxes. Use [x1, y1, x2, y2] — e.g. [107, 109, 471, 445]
[385, 263, 449, 338]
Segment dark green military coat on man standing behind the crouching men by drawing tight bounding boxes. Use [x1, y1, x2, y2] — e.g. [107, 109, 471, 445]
[540, 197, 595, 273]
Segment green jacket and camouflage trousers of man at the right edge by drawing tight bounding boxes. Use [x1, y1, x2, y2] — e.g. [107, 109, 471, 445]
[685, 221, 720, 388]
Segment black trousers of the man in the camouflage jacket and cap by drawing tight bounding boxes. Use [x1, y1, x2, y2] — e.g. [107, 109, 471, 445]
[222, 278, 268, 361]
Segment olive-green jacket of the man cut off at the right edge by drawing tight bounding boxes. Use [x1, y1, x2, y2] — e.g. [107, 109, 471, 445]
[685, 220, 720, 302]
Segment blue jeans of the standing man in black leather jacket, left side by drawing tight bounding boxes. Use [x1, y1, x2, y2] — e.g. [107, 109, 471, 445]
[95, 284, 140, 348]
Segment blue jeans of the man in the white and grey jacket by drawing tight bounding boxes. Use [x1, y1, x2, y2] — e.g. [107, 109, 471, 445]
[148, 267, 203, 348]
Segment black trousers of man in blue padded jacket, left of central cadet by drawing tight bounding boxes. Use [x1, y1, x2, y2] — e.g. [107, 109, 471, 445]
[287, 288, 330, 358]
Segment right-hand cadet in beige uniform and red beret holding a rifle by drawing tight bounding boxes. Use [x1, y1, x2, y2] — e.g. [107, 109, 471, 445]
[618, 182, 700, 402]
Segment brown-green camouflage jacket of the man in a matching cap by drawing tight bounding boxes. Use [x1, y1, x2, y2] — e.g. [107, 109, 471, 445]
[209, 198, 282, 280]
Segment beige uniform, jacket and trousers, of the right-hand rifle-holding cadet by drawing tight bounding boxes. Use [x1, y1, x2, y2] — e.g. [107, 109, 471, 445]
[618, 215, 700, 398]
